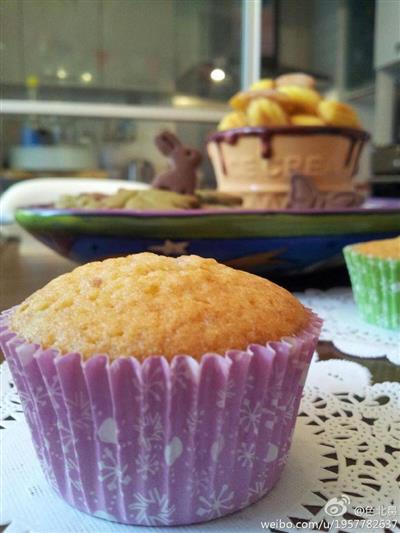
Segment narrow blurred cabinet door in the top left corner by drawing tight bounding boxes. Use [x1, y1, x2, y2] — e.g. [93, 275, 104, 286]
[0, 0, 25, 84]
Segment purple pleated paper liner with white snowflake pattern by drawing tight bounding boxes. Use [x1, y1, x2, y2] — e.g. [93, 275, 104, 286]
[0, 310, 321, 526]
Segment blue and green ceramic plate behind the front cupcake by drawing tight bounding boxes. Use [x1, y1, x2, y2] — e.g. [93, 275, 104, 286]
[16, 199, 400, 275]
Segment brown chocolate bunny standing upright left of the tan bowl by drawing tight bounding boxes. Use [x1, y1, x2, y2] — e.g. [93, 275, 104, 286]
[152, 131, 202, 194]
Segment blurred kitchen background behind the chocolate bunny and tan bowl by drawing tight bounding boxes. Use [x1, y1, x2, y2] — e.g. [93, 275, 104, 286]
[0, 0, 400, 196]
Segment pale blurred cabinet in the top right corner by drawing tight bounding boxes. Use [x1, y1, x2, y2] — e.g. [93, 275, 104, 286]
[375, 0, 400, 69]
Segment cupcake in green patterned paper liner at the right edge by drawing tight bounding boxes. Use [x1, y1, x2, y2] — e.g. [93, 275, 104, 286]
[343, 237, 400, 329]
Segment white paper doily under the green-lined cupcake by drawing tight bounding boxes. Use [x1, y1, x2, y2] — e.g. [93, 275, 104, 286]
[296, 288, 400, 365]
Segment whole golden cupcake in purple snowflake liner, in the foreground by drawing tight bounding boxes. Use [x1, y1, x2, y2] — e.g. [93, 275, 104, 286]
[0, 253, 321, 526]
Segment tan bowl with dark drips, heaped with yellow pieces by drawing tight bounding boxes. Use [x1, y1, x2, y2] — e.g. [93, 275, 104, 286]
[207, 73, 369, 209]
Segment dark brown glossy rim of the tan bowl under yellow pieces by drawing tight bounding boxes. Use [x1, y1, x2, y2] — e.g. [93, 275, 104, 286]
[207, 126, 371, 142]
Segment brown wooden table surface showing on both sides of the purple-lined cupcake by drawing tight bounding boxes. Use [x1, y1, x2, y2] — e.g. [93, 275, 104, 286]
[0, 232, 400, 532]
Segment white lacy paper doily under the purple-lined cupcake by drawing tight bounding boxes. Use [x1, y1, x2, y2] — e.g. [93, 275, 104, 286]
[0, 358, 400, 533]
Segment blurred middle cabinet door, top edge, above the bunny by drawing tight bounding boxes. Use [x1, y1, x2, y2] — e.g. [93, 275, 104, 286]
[102, 0, 176, 92]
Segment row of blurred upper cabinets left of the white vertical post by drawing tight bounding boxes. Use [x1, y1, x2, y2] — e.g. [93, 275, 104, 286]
[0, 0, 241, 97]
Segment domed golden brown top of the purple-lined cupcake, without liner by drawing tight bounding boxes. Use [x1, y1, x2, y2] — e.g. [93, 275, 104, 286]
[11, 253, 309, 359]
